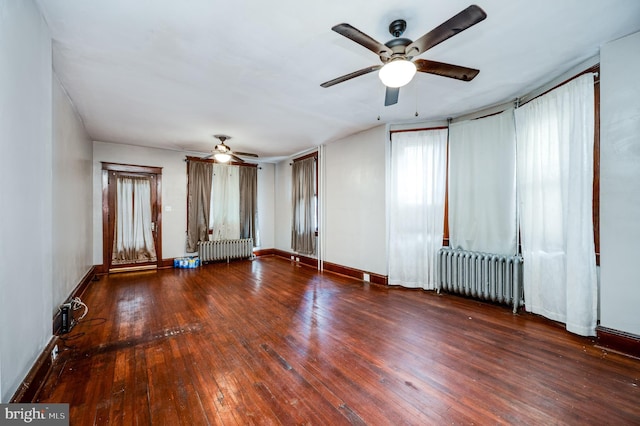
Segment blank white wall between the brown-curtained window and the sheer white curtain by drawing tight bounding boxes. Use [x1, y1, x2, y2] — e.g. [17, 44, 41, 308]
[321, 126, 387, 275]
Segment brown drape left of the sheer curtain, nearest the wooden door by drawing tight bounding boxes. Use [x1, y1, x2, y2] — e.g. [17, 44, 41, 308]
[187, 161, 213, 253]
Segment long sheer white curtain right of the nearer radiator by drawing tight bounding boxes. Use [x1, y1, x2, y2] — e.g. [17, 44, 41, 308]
[515, 74, 597, 336]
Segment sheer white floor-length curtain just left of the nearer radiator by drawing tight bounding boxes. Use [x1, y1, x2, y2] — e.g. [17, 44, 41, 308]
[389, 129, 447, 290]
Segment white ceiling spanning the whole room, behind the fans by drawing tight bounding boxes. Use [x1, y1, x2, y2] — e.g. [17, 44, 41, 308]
[37, 0, 640, 158]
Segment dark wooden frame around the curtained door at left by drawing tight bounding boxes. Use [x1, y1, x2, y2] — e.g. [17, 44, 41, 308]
[102, 161, 162, 273]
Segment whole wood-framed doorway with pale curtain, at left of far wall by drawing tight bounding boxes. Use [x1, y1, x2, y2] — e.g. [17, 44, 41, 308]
[102, 162, 162, 272]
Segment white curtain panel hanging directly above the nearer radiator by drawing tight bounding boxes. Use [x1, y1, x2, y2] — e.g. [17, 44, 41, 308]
[449, 109, 517, 255]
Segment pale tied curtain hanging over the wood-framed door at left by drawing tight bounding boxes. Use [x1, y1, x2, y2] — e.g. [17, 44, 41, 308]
[111, 176, 157, 265]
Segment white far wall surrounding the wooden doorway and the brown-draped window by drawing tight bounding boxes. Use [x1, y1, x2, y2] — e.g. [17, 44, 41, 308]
[93, 142, 274, 265]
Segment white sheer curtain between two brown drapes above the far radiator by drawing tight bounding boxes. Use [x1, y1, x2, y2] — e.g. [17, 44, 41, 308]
[210, 164, 240, 240]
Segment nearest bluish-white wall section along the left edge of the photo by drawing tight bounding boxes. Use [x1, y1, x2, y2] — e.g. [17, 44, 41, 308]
[0, 0, 53, 402]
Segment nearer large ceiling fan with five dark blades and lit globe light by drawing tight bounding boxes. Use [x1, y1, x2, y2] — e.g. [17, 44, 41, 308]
[320, 5, 487, 106]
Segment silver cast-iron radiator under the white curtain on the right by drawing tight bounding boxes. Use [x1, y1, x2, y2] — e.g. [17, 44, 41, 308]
[437, 247, 524, 314]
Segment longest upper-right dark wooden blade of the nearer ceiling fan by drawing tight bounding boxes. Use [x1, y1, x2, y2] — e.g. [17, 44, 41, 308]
[405, 4, 487, 58]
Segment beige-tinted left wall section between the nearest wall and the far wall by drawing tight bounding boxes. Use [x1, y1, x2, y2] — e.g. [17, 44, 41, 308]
[52, 76, 93, 314]
